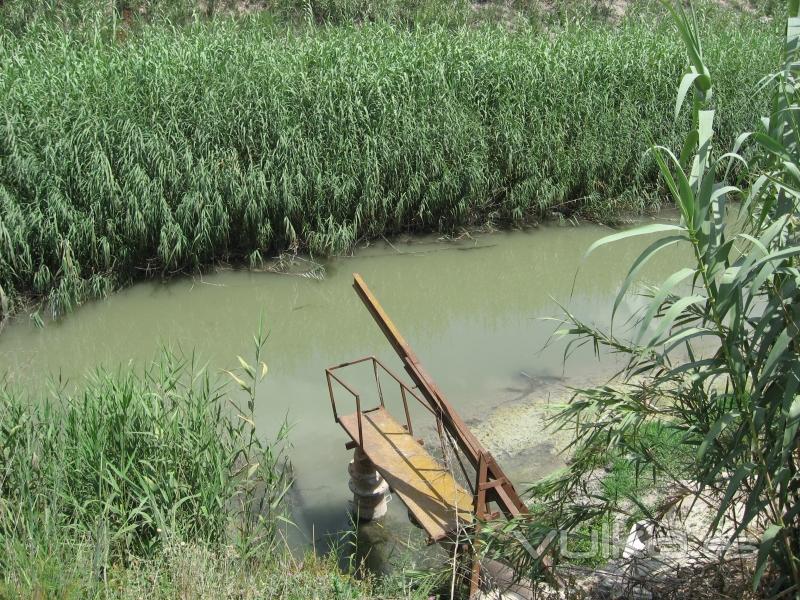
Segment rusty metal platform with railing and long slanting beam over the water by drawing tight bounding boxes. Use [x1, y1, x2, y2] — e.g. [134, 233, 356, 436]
[325, 274, 549, 598]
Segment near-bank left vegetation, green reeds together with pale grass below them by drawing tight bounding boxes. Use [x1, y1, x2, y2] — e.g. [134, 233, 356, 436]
[0, 338, 418, 599]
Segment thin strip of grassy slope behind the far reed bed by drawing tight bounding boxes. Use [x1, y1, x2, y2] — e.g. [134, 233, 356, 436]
[0, 0, 768, 36]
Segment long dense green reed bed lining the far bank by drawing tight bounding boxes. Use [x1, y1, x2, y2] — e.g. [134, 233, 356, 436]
[0, 11, 781, 315]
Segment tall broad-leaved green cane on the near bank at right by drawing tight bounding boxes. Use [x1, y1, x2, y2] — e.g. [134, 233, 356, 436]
[494, 0, 800, 597]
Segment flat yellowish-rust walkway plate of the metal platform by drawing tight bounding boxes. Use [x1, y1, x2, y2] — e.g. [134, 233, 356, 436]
[339, 407, 473, 542]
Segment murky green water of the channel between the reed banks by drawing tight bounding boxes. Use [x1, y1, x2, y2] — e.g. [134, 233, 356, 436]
[0, 216, 688, 552]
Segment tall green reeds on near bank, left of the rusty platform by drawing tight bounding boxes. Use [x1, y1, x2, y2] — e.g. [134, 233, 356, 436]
[0, 336, 291, 589]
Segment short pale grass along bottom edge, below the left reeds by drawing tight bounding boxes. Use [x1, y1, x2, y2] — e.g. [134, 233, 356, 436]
[0, 543, 390, 600]
